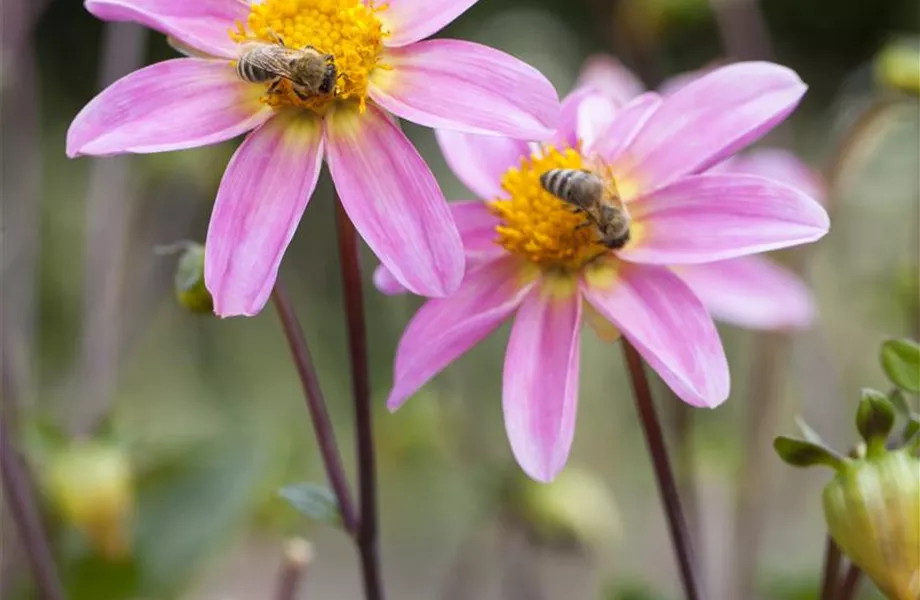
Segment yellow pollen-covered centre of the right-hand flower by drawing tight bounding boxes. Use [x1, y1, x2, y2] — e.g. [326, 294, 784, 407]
[489, 146, 608, 271]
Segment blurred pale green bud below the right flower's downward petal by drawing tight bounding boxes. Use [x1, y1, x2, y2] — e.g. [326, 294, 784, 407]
[513, 466, 620, 550]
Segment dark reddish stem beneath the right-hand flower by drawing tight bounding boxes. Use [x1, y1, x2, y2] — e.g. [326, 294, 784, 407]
[622, 338, 700, 600]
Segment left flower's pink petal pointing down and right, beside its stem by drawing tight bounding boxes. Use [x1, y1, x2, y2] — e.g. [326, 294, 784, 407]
[326, 105, 464, 296]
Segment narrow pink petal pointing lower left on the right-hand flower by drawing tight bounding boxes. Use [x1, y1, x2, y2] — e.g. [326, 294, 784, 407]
[387, 258, 532, 410]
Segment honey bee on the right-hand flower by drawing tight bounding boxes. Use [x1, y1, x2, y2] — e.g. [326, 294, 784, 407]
[540, 169, 632, 250]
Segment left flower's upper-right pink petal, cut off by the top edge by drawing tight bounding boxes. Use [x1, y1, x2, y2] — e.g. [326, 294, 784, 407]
[378, 0, 478, 48]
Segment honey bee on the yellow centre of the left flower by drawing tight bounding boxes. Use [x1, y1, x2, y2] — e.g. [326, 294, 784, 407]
[236, 36, 338, 100]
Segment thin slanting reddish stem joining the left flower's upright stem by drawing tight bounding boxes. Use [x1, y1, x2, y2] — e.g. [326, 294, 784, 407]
[272, 279, 358, 536]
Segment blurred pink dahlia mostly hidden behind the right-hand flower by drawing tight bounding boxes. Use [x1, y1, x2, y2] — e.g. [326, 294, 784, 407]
[578, 55, 826, 330]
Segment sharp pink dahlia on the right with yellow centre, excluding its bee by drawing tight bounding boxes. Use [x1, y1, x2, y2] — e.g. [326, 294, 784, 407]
[375, 62, 829, 481]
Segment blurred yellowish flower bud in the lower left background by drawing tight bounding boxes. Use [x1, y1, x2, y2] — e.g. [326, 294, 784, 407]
[46, 441, 134, 559]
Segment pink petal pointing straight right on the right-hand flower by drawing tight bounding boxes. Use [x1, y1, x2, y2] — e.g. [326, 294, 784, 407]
[618, 174, 830, 265]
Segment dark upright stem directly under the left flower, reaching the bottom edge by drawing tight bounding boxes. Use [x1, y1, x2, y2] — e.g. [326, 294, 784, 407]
[336, 202, 384, 600]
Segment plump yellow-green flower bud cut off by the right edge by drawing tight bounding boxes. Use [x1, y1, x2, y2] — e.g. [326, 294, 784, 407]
[824, 450, 920, 600]
